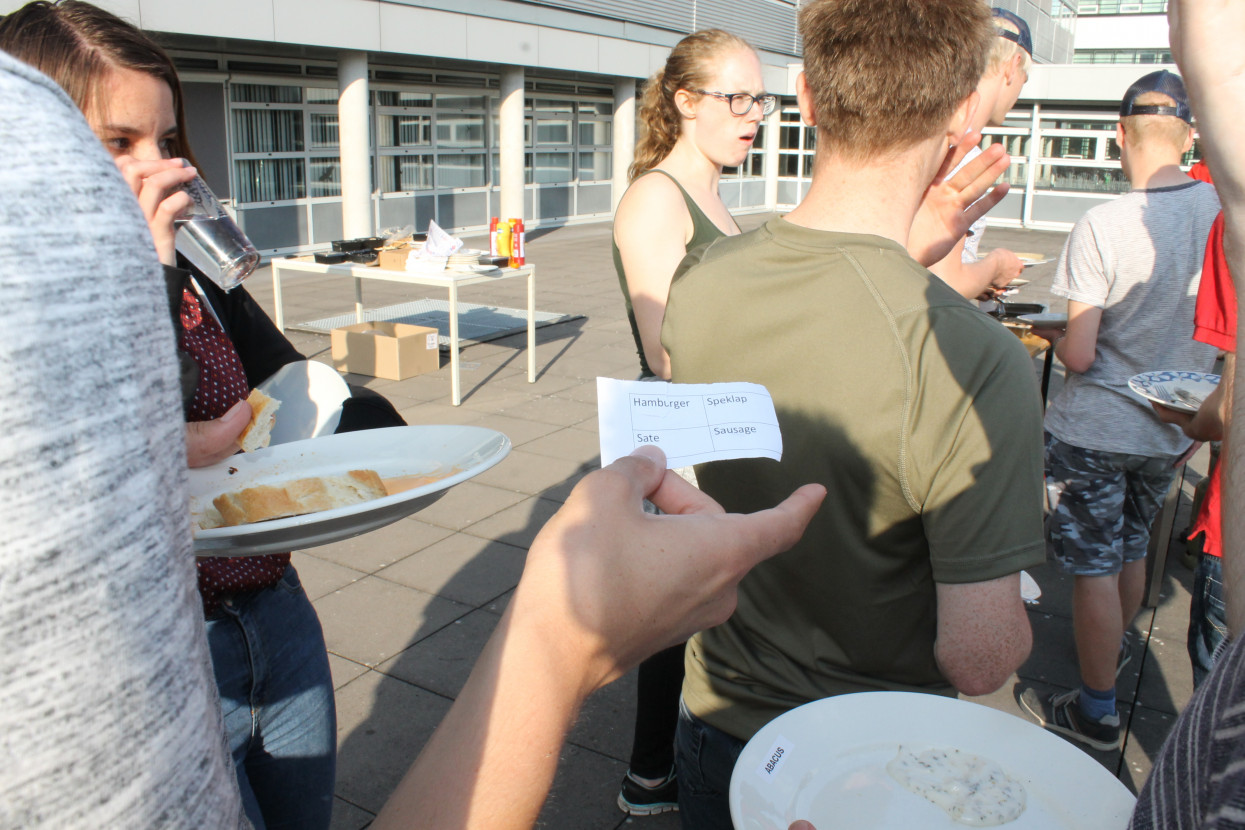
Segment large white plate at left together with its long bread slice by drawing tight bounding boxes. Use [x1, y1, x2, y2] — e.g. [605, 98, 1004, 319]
[189, 426, 510, 556]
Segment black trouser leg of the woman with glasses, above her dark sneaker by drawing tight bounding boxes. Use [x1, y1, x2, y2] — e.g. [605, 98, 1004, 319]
[631, 643, 684, 778]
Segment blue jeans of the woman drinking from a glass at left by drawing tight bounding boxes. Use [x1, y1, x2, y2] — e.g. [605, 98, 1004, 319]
[207, 565, 337, 830]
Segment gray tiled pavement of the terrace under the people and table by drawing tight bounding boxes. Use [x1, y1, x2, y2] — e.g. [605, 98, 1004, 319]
[240, 217, 1205, 830]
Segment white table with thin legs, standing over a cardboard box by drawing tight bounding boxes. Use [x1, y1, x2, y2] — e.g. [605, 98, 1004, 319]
[271, 259, 537, 406]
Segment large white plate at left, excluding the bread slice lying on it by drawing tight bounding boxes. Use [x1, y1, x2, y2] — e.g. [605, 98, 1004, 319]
[189, 426, 510, 556]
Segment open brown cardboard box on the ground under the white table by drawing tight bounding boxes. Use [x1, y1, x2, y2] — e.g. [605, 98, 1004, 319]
[330, 322, 441, 381]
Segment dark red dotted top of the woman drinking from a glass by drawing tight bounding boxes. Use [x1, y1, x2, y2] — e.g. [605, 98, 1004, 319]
[178, 289, 290, 617]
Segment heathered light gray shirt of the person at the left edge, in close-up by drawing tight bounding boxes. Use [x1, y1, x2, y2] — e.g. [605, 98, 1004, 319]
[0, 52, 249, 830]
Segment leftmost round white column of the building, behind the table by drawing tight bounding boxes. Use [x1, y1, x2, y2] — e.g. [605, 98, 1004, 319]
[337, 51, 374, 239]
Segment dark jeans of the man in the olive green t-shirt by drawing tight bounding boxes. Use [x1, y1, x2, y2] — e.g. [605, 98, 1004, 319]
[675, 702, 747, 830]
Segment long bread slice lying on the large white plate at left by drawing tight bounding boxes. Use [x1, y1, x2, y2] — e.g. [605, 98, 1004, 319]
[212, 470, 388, 528]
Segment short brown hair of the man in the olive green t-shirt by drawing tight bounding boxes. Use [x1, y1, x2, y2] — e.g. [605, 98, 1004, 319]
[799, 0, 995, 159]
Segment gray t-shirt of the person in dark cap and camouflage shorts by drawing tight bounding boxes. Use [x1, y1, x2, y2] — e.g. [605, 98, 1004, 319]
[1046, 182, 1219, 458]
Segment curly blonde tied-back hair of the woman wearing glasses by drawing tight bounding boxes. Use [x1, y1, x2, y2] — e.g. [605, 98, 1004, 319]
[627, 29, 752, 182]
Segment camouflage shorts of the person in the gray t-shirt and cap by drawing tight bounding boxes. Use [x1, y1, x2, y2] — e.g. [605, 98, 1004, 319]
[1046, 433, 1175, 576]
